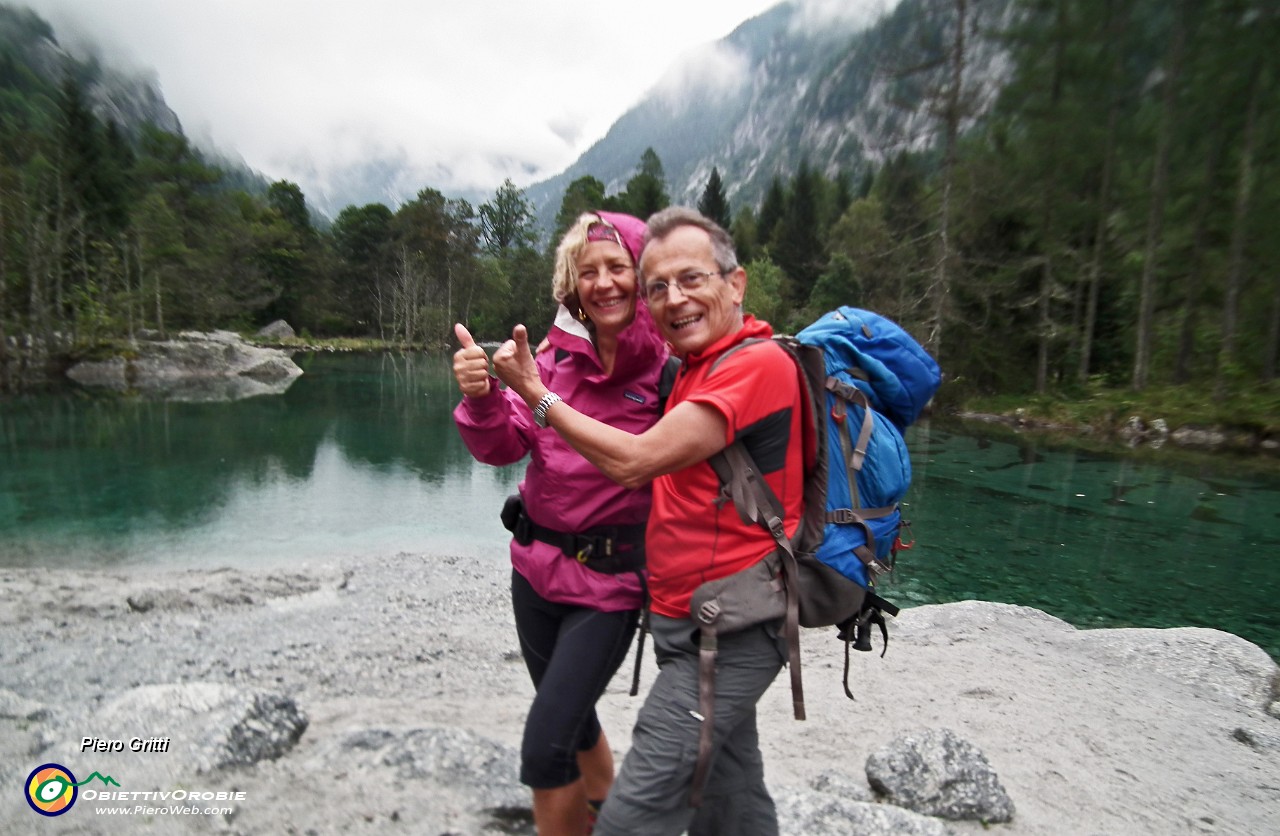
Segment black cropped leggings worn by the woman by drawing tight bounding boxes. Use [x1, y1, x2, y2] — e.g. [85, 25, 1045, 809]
[511, 570, 640, 790]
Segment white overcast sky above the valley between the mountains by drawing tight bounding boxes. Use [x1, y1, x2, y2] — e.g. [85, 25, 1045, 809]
[20, 0, 883, 211]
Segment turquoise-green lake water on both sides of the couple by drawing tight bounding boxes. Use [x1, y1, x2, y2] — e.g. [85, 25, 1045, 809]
[0, 355, 1280, 658]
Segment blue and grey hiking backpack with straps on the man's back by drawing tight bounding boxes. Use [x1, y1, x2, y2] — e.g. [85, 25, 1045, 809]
[710, 306, 942, 691]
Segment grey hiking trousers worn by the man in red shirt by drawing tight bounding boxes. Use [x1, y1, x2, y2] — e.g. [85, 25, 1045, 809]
[594, 606, 786, 836]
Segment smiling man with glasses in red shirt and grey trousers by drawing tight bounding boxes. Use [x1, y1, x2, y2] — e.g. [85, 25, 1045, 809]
[494, 207, 804, 836]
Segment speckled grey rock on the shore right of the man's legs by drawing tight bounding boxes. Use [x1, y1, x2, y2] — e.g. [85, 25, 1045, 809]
[867, 728, 1014, 822]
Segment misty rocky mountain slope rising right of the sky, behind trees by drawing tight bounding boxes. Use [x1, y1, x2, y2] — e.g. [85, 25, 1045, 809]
[526, 0, 1011, 228]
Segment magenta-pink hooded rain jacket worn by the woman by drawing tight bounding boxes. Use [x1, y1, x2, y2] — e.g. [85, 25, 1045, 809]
[453, 213, 667, 612]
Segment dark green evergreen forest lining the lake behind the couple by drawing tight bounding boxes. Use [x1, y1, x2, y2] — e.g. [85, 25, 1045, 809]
[0, 0, 1280, 429]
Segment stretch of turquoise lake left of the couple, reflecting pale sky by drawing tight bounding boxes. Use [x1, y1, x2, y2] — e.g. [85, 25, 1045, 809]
[0, 356, 524, 565]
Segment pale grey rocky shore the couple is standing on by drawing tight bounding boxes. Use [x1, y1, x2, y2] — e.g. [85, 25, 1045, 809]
[0, 554, 1280, 836]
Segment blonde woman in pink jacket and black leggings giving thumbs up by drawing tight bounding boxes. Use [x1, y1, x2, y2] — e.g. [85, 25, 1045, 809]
[453, 213, 667, 836]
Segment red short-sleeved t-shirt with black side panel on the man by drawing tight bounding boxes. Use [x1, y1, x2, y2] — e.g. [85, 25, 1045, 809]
[645, 316, 804, 618]
